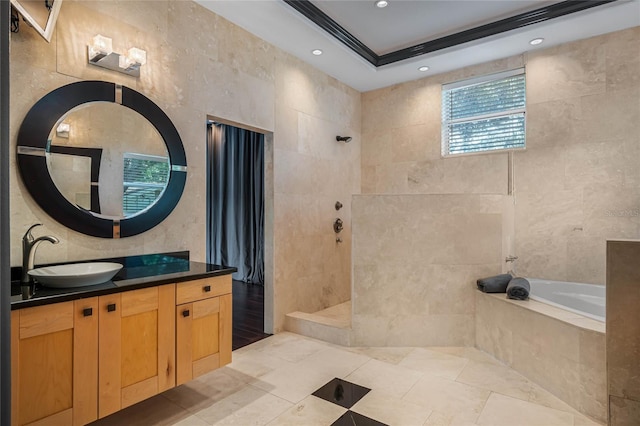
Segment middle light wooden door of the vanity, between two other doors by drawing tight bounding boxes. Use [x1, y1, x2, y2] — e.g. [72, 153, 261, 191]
[98, 284, 175, 418]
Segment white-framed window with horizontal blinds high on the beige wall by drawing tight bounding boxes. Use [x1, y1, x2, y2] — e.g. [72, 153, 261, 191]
[442, 69, 525, 156]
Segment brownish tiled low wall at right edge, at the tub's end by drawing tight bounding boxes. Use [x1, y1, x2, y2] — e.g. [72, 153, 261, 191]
[607, 241, 640, 426]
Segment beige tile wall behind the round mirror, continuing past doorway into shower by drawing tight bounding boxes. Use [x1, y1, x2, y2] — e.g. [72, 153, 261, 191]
[10, 0, 361, 331]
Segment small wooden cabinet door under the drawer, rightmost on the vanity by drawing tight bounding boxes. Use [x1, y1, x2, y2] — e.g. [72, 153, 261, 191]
[176, 294, 232, 385]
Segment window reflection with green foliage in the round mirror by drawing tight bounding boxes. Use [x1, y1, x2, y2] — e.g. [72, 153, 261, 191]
[122, 152, 169, 217]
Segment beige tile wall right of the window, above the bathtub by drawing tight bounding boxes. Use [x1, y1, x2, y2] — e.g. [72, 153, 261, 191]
[514, 28, 640, 284]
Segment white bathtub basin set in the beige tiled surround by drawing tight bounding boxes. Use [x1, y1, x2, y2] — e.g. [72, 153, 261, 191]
[527, 278, 606, 322]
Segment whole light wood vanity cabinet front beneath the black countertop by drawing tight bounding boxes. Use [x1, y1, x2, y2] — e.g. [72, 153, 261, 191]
[11, 275, 232, 426]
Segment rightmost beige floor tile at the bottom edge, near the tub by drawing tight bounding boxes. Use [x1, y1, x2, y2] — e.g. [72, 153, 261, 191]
[477, 393, 573, 426]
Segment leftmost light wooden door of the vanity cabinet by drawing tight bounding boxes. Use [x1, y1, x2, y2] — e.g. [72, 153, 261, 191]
[11, 297, 98, 426]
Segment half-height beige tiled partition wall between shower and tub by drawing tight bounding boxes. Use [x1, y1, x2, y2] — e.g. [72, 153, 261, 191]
[351, 194, 503, 346]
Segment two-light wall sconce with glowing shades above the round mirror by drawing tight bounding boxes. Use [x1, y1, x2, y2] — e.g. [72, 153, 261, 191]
[88, 34, 147, 77]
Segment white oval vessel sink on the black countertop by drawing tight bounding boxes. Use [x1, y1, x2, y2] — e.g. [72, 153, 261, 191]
[29, 262, 122, 288]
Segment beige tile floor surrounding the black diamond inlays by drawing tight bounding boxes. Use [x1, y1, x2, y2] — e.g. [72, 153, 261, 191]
[93, 333, 600, 426]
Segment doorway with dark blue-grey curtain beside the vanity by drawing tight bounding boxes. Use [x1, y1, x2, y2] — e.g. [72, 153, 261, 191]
[206, 120, 269, 350]
